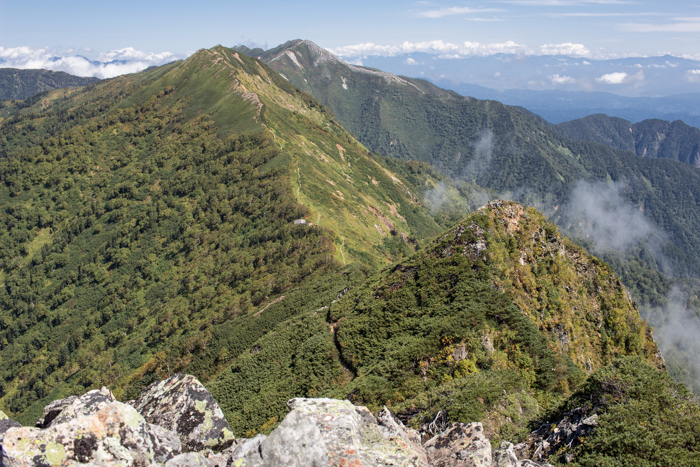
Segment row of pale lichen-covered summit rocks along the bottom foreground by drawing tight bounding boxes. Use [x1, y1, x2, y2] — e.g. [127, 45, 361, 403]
[0, 374, 548, 467]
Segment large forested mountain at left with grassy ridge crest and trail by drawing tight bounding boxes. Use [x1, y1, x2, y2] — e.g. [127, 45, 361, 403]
[0, 47, 466, 422]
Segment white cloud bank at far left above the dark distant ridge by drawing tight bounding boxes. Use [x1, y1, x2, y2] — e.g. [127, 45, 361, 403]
[0, 47, 189, 78]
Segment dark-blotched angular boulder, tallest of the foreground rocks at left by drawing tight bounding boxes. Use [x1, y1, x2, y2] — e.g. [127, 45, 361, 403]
[130, 374, 234, 451]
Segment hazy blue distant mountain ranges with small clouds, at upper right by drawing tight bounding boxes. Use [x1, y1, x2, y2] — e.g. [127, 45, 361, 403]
[349, 54, 700, 127]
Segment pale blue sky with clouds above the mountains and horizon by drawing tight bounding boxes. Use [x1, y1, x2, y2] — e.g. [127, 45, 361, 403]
[0, 0, 700, 82]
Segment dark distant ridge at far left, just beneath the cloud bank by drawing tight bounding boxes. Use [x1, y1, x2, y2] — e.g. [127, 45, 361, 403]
[0, 68, 99, 100]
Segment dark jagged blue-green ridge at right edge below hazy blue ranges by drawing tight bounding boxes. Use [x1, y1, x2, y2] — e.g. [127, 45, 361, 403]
[553, 114, 700, 167]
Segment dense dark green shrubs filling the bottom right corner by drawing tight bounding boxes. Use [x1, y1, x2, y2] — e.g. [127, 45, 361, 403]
[561, 357, 700, 467]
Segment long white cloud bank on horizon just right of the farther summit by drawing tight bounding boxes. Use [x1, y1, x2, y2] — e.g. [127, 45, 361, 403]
[330, 40, 532, 58]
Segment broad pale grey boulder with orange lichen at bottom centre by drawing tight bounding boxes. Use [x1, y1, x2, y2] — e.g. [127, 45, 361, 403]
[241, 398, 427, 467]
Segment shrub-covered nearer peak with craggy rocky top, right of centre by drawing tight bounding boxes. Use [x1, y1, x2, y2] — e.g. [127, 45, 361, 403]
[209, 202, 663, 442]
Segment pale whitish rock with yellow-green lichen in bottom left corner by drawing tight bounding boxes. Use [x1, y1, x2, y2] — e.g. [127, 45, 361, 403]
[0, 401, 181, 467]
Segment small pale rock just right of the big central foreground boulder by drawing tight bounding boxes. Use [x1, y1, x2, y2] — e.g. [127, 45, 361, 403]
[423, 423, 491, 467]
